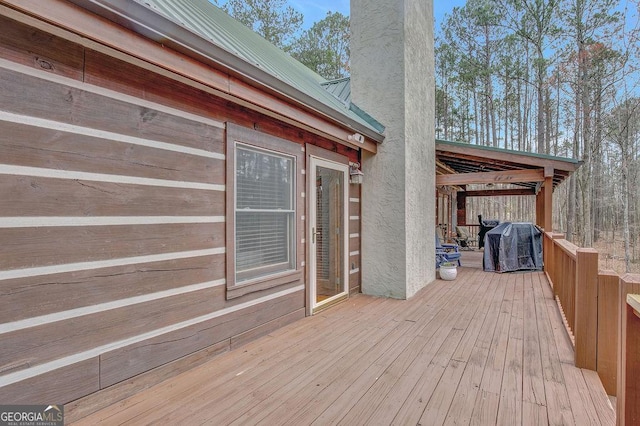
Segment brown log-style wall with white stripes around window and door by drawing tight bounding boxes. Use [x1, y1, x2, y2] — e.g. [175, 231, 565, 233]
[0, 9, 360, 406]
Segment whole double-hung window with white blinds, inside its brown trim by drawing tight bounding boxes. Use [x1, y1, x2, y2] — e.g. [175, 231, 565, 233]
[235, 144, 296, 282]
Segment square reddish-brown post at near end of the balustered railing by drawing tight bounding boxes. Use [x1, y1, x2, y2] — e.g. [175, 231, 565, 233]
[573, 248, 598, 371]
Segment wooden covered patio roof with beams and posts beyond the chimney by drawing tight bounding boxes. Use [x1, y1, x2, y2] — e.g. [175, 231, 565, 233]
[436, 140, 582, 230]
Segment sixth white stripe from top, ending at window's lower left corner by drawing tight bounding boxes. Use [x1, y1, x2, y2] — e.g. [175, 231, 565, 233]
[0, 279, 226, 334]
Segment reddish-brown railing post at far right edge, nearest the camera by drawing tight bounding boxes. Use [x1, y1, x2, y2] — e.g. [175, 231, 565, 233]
[616, 274, 640, 426]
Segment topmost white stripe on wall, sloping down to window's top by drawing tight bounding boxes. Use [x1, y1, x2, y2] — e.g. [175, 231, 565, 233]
[0, 59, 225, 129]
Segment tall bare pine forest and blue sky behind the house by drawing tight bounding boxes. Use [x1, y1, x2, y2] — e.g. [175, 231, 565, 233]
[212, 0, 640, 273]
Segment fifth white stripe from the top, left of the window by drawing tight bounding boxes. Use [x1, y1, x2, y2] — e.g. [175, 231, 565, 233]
[0, 247, 226, 280]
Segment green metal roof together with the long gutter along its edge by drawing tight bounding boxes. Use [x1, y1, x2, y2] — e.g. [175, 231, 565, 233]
[71, 0, 384, 142]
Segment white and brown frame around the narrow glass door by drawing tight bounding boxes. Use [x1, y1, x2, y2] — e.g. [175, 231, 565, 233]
[306, 144, 349, 315]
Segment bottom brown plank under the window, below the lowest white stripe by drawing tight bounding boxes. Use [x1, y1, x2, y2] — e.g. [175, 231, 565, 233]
[100, 292, 304, 387]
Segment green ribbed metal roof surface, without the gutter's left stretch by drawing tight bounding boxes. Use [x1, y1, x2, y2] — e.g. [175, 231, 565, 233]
[129, 0, 381, 134]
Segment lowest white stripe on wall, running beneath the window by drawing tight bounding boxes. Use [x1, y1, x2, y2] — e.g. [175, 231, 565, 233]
[0, 285, 304, 386]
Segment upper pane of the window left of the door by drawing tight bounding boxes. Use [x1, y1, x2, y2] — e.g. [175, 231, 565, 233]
[236, 147, 293, 210]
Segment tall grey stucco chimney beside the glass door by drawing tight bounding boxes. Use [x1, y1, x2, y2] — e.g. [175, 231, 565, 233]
[351, 0, 435, 299]
